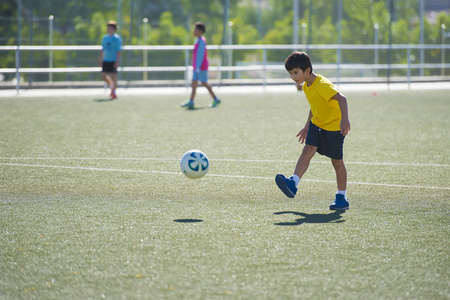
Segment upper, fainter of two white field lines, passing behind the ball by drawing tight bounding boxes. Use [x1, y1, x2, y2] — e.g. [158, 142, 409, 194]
[0, 157, 450, 168]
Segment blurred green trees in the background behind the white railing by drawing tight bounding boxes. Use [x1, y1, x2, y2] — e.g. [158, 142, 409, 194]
[0, 0, 450, 79]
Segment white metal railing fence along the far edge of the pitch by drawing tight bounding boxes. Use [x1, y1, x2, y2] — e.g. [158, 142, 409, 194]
[0, 44, 450, 92]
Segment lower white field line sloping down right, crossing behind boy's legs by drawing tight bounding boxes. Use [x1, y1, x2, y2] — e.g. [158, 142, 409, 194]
[0, 163, 450, 190]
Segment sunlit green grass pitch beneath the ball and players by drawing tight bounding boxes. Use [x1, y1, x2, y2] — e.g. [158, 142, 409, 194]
[0, 87, 450, 299]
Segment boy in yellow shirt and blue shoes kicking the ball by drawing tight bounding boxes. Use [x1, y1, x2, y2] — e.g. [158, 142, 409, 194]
[275, 52, 350, 210]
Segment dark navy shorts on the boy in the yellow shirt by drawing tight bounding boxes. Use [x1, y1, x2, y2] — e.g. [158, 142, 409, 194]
[306, 122, 345, 159]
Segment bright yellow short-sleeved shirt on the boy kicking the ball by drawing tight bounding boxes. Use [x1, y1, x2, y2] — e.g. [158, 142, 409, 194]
[303, 74, 341, 131]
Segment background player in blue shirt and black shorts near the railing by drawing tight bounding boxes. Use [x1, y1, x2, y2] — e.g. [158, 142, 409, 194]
[99, 21, 122, 99]
